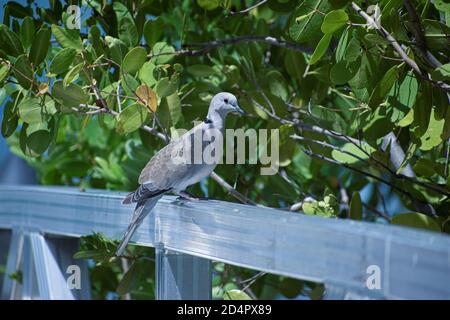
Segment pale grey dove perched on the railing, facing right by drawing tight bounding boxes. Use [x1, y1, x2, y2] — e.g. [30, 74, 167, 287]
[116, 92, 244, 256]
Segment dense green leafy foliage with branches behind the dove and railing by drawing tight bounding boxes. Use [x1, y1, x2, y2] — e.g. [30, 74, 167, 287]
[0, 0, 450, 297]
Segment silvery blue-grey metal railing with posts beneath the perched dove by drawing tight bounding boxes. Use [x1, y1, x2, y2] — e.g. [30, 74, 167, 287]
[0, 186, 450, 299]
